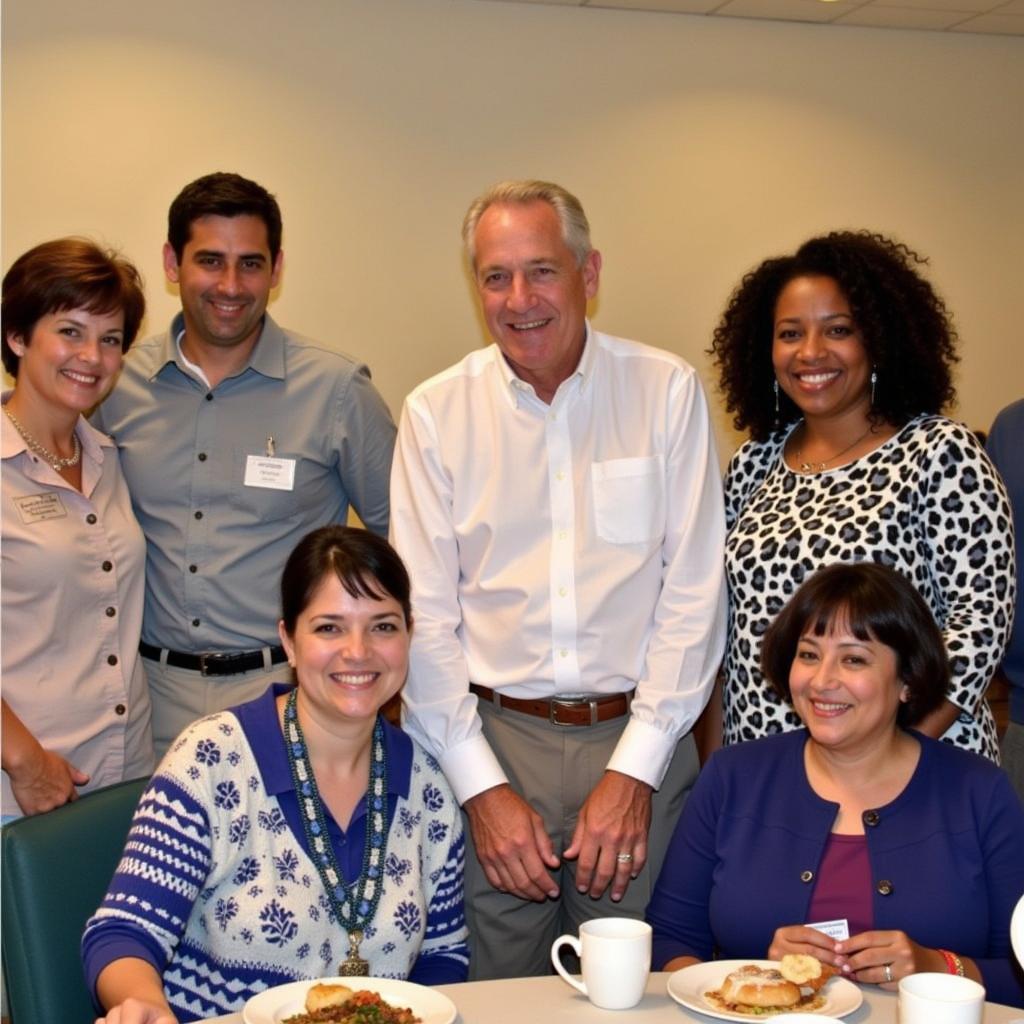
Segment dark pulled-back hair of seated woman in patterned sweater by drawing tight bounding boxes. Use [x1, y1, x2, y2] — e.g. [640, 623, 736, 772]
[281, 525, 413, 636]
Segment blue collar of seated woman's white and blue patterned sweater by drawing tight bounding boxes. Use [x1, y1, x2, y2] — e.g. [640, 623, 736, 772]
[231, 683, 413, 799]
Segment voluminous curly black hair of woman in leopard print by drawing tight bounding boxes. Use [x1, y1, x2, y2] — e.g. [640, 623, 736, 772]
[708, 231, 958, 441]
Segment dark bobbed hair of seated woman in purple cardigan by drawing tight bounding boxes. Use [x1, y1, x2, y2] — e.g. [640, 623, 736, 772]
[761, 562, 949, 727]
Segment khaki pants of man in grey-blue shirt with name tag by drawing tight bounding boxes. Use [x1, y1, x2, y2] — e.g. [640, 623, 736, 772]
[142, 657, 292, 761]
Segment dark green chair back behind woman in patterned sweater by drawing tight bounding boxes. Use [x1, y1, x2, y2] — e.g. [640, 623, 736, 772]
[0, 779, 148, 1024]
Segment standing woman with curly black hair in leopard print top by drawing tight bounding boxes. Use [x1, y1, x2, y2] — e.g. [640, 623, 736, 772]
[711, 231, 1014, 761]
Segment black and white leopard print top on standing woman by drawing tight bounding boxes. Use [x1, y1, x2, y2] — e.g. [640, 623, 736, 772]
[724, 415, 1015, 763]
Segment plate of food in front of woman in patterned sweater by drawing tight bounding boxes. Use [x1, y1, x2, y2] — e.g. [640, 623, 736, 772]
[242, 978, 456, 1024]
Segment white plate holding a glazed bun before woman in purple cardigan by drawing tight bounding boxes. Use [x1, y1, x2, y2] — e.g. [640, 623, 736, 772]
[669, 954, 864, 1021]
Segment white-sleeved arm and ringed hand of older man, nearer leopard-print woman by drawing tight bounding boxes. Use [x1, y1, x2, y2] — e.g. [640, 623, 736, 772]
[564, 370, 726, 899]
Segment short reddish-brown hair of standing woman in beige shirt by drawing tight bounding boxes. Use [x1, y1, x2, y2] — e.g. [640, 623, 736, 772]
[0, 238, 145, 377]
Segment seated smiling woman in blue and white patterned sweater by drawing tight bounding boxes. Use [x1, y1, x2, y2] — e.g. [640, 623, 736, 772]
[82, 526, 468, 1024]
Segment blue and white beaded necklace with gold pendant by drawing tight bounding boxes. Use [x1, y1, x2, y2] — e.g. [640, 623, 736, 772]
[285, 690, 387, 977]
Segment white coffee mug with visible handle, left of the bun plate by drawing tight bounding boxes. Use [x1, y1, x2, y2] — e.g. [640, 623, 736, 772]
[551, 918, 651, 1010]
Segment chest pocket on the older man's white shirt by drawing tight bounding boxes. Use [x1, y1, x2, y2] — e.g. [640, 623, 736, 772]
[591, 455, 665, 544]
